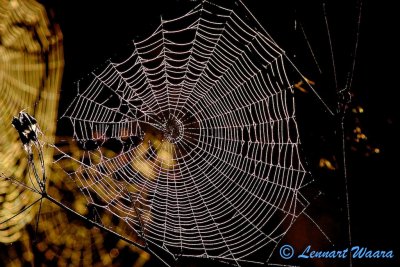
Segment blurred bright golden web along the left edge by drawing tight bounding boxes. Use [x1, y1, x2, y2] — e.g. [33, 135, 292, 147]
[0, 0, 64, 247]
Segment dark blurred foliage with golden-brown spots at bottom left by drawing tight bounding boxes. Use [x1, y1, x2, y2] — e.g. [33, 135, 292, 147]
[35, 137, 150, 267]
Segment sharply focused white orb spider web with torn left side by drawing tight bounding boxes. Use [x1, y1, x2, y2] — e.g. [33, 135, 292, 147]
[56, 1, 308, 265]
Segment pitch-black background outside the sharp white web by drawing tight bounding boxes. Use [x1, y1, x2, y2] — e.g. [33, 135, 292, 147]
[42, 0, 400, 266]
